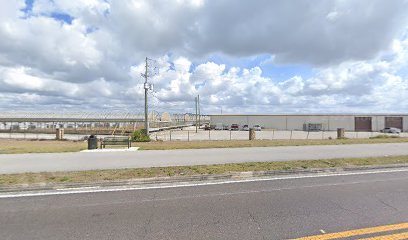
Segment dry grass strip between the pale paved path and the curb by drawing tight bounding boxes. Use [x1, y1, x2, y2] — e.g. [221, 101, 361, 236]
[0, 156, 408, 187]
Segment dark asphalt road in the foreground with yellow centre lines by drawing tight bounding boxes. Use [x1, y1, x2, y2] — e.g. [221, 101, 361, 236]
[0, 169, 408, 240]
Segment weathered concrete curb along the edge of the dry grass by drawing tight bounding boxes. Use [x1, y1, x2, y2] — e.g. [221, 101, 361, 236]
[0, 164, 408, 195]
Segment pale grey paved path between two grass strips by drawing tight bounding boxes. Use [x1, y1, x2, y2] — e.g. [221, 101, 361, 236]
[0, 143, 408, 174]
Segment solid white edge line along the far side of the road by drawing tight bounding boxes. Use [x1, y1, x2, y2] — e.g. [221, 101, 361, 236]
[0, 168, 408, 199]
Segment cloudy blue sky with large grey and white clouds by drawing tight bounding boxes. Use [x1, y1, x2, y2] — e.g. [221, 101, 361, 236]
[0, 0, 408, 114]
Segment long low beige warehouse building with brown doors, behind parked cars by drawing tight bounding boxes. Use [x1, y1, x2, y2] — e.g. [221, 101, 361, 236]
[210, 114, 408, 132]
